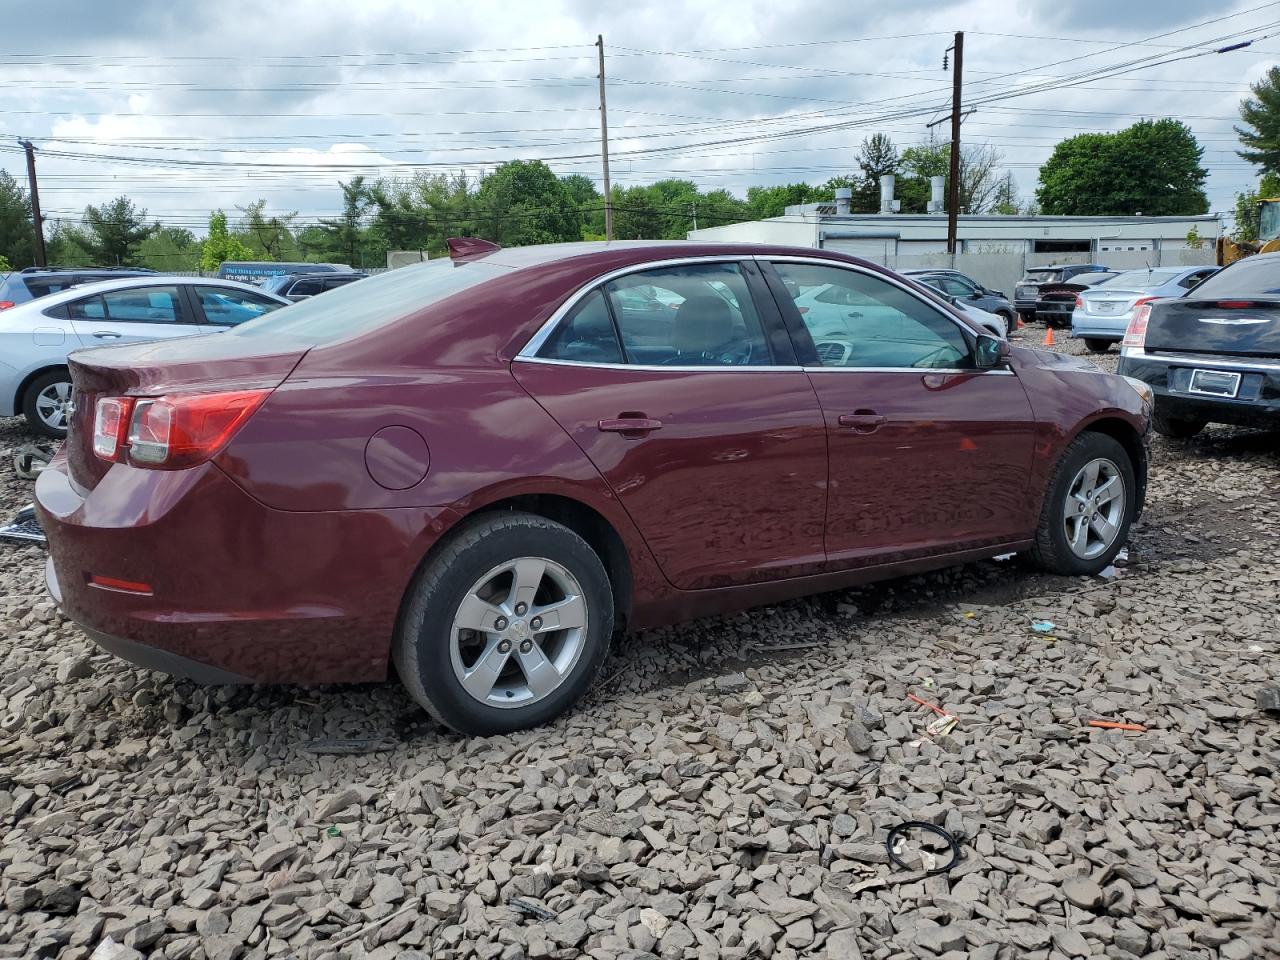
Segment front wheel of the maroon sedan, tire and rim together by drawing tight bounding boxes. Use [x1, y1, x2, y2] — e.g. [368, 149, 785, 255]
[1032, 431, 1138, 576]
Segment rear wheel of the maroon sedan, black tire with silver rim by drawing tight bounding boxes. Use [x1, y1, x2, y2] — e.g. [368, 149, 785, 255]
[392, 513, 613, 736]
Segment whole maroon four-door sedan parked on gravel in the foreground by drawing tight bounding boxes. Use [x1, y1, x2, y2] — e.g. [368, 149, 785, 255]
[36, 241, 1149, 733]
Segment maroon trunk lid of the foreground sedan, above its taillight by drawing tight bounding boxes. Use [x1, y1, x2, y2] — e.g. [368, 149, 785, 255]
[65, 335, 310, 489]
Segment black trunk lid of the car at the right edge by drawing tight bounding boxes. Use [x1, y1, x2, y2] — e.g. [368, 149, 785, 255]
[1144, 297, 1280, 357]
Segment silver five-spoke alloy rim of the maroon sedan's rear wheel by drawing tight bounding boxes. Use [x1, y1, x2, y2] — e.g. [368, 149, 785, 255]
[449, 557, 588, 708]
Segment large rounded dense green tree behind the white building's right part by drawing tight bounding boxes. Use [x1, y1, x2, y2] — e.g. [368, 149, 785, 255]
[1036, 119, 1208, 216]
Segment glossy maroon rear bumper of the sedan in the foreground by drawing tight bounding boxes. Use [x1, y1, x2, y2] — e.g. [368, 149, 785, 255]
[36, 457, 460, 684]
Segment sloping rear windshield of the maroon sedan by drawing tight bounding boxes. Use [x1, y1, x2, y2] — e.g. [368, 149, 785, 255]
[225, 257, 509, 343]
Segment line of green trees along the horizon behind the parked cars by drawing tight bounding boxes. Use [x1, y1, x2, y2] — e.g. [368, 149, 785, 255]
[0, 112, 1228, 271]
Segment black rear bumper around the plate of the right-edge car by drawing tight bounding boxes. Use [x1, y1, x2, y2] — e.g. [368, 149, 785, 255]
[1116, 348, 1280, 428]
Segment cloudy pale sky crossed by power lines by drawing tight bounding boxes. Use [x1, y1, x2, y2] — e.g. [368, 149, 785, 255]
[0, 0, 1280, 233]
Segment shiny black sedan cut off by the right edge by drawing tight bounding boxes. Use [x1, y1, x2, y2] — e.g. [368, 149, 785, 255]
[1119, 253, 1280, 438]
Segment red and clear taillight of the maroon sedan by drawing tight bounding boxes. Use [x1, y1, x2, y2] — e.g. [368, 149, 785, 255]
[93, 389, 271, 470]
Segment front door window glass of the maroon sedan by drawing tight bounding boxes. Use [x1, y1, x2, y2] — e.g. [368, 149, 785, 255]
[774, 262, 973, 369]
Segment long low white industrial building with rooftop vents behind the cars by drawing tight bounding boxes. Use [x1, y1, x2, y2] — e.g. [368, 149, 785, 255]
[689, 178, 1222, 291]
